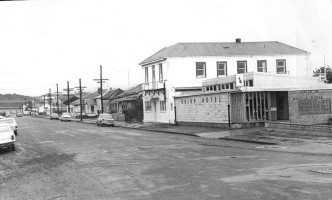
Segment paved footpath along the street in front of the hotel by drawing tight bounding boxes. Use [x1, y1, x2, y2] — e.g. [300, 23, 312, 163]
[37, 116, 332, 156]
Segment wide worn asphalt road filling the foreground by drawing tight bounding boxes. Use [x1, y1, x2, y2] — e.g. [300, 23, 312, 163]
[0, 117, 332, 200]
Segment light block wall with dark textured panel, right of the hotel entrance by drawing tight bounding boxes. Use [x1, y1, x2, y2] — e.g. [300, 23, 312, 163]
[288, 90, 332, 124]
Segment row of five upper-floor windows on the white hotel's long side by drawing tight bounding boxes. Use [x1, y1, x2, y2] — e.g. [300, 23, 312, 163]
[196, 59, 286, 77]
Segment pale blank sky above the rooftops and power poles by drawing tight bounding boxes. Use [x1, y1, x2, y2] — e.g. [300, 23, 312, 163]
[0, 0, 332, 95]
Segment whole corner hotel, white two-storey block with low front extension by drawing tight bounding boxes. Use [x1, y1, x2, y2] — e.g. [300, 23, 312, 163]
[139, 39, 332, 126]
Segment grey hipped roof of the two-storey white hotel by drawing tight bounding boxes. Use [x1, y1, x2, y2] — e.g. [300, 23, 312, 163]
[139, 41, 308, 65]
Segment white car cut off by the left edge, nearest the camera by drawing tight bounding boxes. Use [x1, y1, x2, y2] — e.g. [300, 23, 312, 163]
[0, 124, 16, 151]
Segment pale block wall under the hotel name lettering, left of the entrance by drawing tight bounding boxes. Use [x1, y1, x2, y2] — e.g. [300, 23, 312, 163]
[175, 93, 228, 123]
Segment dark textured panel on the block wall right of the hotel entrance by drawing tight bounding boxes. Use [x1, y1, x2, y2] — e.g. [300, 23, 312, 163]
[293, 96, 331, 115]
